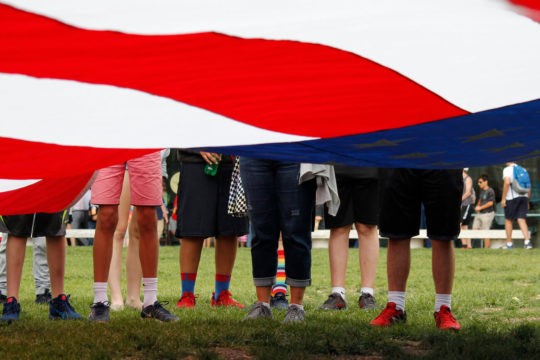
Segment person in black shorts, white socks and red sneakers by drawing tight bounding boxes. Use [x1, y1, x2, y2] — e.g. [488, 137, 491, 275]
[370, 169, 463, 330]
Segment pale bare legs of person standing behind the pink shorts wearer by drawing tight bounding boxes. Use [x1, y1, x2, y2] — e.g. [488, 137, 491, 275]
[108, 171, 142, 310]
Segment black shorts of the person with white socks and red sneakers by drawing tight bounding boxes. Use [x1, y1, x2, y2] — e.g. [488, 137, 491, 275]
[379, 169, 463, 240]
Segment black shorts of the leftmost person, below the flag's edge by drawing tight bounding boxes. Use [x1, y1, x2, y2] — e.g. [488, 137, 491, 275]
[2, 210, 68, 238]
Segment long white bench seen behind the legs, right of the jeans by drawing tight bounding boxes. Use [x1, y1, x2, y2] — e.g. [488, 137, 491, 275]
[311, 229, 524, 249]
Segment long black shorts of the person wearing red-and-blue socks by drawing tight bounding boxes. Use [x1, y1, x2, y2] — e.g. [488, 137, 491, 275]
[175, 162, 248, 238]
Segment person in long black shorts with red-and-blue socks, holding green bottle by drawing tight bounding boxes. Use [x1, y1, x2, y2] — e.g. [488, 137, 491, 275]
[176, 150, 248, 308]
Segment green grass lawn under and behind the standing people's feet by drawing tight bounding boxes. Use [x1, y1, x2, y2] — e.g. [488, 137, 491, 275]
[0, 247, 540, 359]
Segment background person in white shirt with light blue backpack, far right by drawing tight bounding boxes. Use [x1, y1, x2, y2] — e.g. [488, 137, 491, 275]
[501, 162, 532, 249]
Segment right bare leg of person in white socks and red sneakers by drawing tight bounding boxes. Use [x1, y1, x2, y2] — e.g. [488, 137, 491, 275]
[431, 239, 455, 294]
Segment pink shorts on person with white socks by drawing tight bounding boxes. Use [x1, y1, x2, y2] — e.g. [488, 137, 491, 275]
[92, 151, 163, 206]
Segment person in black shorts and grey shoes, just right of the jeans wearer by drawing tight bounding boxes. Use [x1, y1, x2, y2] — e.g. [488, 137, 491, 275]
[320, 165, 380, 310]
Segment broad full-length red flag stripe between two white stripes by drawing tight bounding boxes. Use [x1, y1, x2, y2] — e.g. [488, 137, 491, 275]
[0, 5, 466, 137]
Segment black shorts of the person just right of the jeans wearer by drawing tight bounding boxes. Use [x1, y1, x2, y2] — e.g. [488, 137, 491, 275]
[324, 175, 380, 229]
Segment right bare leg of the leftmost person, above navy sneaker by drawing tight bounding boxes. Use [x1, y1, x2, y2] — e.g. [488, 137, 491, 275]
[47, 236, 66, 298]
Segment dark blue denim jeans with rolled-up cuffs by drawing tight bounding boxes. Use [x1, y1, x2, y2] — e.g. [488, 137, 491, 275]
[240, 157, 316, 287]
